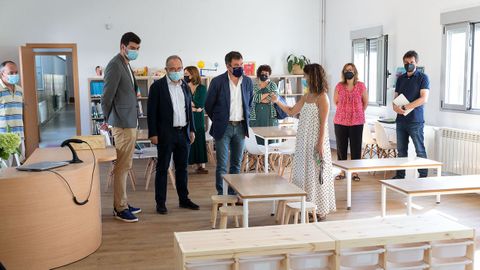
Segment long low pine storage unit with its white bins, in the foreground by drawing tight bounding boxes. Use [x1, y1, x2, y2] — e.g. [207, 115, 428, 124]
[174, 214, 475, 270]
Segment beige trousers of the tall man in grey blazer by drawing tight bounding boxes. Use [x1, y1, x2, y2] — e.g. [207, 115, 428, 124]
[112, 127, 137, 212]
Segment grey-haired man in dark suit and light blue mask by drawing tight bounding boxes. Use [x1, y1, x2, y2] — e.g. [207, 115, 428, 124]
[147, 55, 200, 215]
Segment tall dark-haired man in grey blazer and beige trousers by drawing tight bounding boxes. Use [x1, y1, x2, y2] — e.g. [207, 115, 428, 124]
[102, 32, 142, 222]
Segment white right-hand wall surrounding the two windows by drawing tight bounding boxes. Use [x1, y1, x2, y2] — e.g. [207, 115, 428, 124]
[325, 0, 480, 138]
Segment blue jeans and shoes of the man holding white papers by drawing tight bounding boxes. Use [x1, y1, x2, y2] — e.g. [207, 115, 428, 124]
[396, 122, 428, 178]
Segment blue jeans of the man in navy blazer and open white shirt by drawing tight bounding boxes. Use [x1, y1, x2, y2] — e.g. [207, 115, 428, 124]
[215, 124, 245, 195]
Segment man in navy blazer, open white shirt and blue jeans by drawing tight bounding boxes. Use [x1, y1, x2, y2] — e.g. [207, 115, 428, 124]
[205, 51, 253, 194]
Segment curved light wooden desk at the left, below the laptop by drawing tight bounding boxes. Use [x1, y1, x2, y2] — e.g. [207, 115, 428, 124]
[0, 147, 116, 269]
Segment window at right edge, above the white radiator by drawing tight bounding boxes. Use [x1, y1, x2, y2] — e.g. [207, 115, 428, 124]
[441, 22, 480, 111]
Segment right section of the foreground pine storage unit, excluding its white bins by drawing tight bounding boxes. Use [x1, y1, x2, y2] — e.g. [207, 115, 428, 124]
[314, 214, 475, 270]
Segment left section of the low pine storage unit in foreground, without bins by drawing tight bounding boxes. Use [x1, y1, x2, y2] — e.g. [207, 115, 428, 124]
[174, 224, 335, 270]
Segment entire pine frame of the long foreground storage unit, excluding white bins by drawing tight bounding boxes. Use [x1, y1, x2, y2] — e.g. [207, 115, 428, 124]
[174, 214, 475, 270]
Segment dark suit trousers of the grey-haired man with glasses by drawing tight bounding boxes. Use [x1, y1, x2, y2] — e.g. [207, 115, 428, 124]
[155, 128, 190, 204]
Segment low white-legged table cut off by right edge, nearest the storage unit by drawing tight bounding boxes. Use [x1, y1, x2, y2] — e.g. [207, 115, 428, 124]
[380, 175, 480, 216]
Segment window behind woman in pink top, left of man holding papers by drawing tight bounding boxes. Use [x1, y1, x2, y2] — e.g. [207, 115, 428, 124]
[352, 35, 388, 106]
